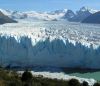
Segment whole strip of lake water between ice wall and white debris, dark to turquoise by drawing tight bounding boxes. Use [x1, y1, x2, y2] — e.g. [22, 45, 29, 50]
[12, 66, 100, 81]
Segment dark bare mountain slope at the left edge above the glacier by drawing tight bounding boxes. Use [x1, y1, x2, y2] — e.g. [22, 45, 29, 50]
[0, 11, 17, 24]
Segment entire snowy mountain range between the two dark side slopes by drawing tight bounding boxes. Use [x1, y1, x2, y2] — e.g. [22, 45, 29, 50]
[0, 7, 97, 22]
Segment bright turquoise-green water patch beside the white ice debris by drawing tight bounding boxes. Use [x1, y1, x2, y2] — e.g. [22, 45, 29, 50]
[69, 71, 100, 81]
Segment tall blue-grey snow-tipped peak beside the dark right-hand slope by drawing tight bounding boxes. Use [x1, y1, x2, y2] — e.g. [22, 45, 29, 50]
[69, 7, 97, 22]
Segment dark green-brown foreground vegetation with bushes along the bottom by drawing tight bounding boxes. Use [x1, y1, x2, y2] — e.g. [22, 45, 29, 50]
[0, 69, 100, 86]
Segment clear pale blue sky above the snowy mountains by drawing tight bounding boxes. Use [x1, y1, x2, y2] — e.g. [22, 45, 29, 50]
[0, 0, 100, 12]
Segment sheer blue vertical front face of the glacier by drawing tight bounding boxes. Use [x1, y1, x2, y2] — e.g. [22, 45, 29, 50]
[0, 36, 100, 68]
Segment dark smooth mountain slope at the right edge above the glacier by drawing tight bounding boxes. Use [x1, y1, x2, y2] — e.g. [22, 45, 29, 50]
[82, 11, 100, 24]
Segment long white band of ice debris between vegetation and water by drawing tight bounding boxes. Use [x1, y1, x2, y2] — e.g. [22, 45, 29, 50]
[18, 71, 96, 86]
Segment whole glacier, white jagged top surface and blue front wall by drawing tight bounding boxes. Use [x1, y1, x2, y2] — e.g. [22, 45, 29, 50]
[0, 21, 100, 69]
